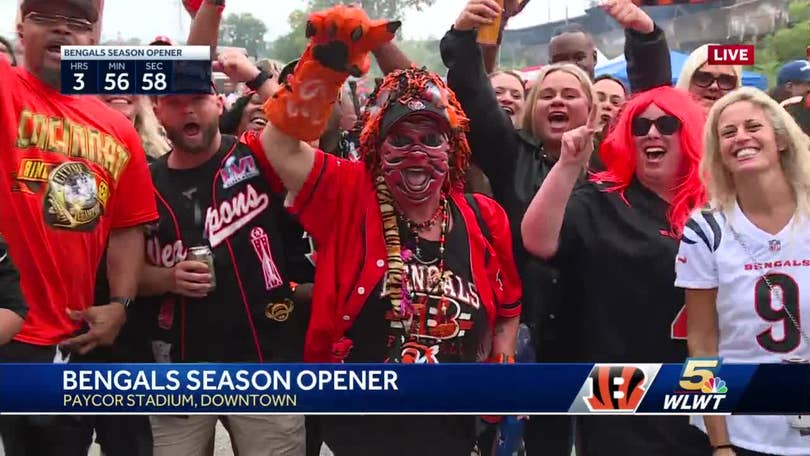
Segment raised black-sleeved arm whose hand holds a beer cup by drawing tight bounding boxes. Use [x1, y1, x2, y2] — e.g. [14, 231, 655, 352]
[441, 0, 518, 195]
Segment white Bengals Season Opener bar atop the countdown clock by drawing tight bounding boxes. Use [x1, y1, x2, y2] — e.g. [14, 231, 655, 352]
[62, 46, 211, 61]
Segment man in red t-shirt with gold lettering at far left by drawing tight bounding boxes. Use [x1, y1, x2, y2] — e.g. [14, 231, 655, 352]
[0, 0, 157, 455]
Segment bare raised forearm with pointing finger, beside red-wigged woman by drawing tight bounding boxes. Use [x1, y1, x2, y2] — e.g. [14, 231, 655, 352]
[520, 109, 597, 259]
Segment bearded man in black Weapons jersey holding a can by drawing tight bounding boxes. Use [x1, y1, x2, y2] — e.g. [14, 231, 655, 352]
[140, 51, 304, 456]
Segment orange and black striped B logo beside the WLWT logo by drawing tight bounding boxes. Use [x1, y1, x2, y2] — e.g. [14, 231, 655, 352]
[583, 365, 647, 412]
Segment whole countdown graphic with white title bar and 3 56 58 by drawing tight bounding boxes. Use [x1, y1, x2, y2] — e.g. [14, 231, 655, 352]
[61, 46, 211, 95]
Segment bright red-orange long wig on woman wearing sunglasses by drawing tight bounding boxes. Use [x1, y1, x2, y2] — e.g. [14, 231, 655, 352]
[591, 86, 707, 237]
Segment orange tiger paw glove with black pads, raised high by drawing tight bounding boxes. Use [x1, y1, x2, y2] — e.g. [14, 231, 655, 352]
[264, 5, 400, 141]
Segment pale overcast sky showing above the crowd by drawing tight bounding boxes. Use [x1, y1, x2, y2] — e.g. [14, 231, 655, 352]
[0, 0, 585, 42]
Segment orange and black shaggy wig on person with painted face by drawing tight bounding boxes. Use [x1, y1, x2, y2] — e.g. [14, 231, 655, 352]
[360, 68, 470, 191]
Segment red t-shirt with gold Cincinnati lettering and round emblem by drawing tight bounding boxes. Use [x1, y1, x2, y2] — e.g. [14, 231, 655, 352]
[0, 59, 157, 345]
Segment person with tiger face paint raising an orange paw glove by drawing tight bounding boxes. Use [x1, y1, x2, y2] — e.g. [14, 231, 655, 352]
[262, 6, 521, 456]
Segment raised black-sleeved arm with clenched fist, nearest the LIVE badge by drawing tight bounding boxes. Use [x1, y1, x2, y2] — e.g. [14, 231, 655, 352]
[603, 0, 672, 93]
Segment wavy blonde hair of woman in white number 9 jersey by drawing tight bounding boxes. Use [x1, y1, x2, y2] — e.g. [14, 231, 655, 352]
[700, 87, 810, 217]
